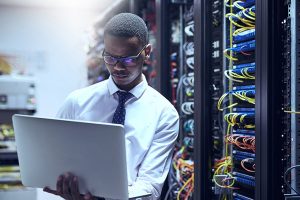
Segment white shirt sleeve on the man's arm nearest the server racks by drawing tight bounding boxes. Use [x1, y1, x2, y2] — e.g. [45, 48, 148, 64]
[129, 107, 179, 200]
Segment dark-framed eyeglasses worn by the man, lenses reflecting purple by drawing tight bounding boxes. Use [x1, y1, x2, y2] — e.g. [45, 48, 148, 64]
[102, 45, 147, 67]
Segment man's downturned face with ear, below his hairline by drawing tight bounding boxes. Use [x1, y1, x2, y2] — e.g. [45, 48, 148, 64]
[104, 34, 151, 91]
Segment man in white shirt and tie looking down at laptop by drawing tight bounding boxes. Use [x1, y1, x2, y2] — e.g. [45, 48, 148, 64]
[44, 13, 179, 200]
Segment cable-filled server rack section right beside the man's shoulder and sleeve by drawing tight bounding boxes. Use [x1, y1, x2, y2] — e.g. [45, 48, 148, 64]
[156, 0, 194, 199]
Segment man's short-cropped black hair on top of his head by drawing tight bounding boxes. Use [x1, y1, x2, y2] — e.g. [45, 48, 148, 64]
[104, 13, 149, 46]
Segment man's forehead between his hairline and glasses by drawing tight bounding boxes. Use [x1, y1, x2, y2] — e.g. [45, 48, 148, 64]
[104, 34, 141, 56]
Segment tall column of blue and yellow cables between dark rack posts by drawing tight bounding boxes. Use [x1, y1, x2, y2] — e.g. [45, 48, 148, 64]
[213, 0, 256, 199]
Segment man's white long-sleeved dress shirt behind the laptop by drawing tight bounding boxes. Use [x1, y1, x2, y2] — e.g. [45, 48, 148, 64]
[58, 76, 179, 199]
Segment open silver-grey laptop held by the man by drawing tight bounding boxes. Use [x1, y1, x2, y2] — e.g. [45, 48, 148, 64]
[13, 114, 151, 200]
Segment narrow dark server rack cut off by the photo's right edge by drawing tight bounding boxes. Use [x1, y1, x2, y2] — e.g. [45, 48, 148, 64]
[276, 0, 300, 199]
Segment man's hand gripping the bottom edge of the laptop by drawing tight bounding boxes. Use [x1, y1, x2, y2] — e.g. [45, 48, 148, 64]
[43, 173, 97, 200]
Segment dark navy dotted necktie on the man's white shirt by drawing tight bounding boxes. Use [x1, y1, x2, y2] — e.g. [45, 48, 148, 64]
[112, 91, 133, 125]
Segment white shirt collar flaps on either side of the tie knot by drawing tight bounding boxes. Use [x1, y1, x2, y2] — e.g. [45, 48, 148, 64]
[107, 74, 148, 98]
